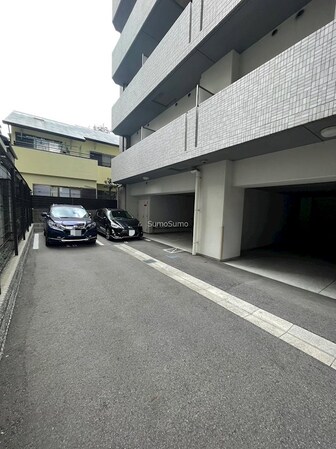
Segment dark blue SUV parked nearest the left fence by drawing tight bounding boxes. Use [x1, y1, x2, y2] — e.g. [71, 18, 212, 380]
[41, 204, 97, 246]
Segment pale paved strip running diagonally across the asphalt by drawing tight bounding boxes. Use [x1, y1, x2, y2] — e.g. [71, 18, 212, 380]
[118, 245, 336, 370]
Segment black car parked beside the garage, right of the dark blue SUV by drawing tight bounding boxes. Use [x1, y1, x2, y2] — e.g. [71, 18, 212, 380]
[94, 209, 143, 240]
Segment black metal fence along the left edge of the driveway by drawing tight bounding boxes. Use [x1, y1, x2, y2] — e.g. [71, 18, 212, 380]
[0, 136, 32, 293]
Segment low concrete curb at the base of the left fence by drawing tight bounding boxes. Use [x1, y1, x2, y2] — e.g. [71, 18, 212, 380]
[0, 225, 34, 360]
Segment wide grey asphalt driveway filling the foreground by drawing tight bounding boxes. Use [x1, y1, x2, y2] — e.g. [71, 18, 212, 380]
[0, 234, 336, 449]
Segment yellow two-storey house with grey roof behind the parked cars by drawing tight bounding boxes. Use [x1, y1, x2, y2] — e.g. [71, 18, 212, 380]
[3, 111, 119, 198]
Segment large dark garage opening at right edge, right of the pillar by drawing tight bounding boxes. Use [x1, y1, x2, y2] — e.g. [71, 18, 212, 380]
[229, 183, 336, 298]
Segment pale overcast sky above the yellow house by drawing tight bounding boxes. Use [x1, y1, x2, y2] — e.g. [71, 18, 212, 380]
[0, 0, 119, 134]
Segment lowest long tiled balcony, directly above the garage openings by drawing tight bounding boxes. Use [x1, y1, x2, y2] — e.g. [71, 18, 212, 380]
[112, 21, 336, 183]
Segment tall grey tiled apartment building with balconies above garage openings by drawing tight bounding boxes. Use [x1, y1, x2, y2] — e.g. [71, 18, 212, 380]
[112, 0, 336, 260]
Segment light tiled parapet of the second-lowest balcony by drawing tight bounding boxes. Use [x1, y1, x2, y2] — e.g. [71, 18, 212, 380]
[112, 0, 242, 135]
